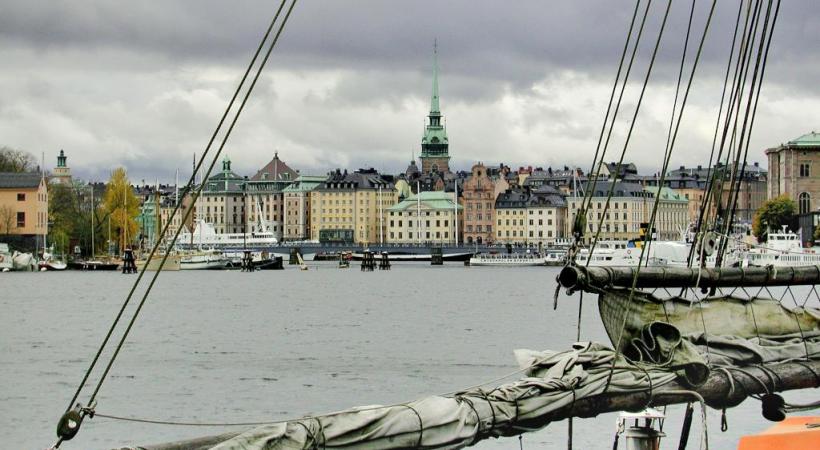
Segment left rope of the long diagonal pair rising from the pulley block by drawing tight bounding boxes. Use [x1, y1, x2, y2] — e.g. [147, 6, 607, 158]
[66, 0, 294, 412]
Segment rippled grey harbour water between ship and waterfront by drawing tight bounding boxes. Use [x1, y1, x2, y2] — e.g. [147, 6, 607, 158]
[0, 263, 817, 450]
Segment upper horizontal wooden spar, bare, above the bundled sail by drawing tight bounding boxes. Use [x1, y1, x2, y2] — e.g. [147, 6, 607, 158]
[558, 266, 820, 292]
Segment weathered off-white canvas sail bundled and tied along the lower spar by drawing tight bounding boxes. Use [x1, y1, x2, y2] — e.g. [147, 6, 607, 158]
[142, 290, 820, 450]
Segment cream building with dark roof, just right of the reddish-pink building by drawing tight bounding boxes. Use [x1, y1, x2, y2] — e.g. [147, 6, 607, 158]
[493, 186, 567, 247]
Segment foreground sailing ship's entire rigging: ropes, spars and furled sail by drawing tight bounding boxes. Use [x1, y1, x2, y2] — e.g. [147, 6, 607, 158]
[48, 0, 820, 450]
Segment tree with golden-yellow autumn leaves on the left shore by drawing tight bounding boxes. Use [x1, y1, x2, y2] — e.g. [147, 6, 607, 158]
[98, 167, 140, 251]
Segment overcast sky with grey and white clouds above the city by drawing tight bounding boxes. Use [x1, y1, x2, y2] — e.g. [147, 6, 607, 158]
[0, 0, 820, 182]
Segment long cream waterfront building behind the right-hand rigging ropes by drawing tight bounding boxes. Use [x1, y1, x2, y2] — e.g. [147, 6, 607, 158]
[565, 181, 689, 244]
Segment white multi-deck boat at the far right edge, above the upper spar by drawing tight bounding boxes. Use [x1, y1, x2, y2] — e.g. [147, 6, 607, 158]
[744, 227, 820, 267]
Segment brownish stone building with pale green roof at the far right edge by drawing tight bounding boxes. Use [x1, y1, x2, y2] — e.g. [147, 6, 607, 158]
[766, 131, 820, 214]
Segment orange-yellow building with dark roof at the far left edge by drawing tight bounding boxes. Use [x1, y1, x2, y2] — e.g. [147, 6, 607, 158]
[0, 172, 48, 237]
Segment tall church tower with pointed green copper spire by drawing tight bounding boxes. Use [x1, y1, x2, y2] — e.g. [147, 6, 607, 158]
[420, 44, 450, 173]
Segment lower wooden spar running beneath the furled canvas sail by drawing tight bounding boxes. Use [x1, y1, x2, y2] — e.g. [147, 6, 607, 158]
[136, 360, 820, 450]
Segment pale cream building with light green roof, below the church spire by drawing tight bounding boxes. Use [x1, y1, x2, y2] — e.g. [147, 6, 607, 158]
[387, 191, 463, 245]
